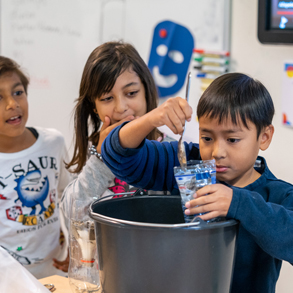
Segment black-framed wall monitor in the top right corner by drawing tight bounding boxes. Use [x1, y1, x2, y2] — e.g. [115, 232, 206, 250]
[258, 0, 293, 44]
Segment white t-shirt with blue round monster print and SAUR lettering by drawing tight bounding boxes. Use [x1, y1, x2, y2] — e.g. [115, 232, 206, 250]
[0, 128, 70, 278]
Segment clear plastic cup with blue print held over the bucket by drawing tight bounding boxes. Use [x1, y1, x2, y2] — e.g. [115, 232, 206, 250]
[174, 160, 216, 223]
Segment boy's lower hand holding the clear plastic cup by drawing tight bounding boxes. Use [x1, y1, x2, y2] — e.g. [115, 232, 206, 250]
[185, 184, 233, 221]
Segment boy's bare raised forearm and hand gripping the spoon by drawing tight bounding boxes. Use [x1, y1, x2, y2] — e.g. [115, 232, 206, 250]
[119, 97, 192, 148]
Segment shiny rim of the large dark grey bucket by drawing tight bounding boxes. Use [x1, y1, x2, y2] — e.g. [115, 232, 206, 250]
[89, 195, 238, 230]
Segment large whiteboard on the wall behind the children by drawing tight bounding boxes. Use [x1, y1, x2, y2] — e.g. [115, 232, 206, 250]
[0, 0, 230, 152]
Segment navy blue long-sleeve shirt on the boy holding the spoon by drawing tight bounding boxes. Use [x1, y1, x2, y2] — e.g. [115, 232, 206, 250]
[102, 125, 293, 293]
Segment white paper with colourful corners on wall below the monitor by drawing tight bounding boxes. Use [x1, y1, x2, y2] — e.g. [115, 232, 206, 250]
[282, 61, 293, 127]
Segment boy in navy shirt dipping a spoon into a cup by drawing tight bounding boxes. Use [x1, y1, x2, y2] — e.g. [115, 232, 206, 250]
[102, 73, 293, 293]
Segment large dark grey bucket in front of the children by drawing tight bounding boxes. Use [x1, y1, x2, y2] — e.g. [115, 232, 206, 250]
[89, 196, 238, 293]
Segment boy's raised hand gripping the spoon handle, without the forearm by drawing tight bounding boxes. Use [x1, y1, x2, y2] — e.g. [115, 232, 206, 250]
[146, 97, 192, 134]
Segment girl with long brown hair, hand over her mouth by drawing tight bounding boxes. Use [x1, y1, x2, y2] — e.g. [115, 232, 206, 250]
[62, 42, 168, 215]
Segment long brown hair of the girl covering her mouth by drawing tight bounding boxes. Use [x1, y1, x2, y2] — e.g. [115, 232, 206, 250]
[66, 42, 162, 173]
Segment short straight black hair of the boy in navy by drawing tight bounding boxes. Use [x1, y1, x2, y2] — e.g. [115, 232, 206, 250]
[197, 73, 275, 138]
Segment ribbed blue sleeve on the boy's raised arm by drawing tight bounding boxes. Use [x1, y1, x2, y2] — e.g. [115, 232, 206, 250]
[102, 122, 199, 191]
